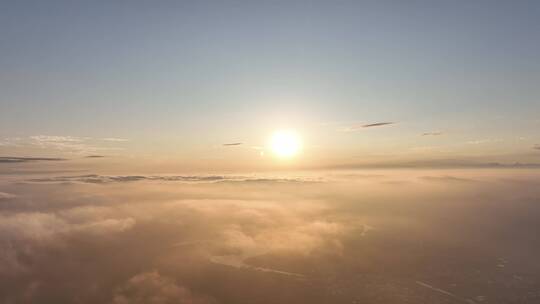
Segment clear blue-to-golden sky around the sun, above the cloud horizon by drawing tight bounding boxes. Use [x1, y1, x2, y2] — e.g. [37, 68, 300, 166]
[0, 1, 540, 171]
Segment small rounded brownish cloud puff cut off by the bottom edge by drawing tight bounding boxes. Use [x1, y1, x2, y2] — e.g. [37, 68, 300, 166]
[111, 271, 216, 304]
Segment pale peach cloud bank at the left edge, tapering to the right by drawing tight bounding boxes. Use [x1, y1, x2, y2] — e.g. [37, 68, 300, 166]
[0, 208, 136, 276]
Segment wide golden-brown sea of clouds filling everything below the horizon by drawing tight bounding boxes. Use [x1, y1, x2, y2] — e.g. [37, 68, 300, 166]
[0, 169, 540, 304]
